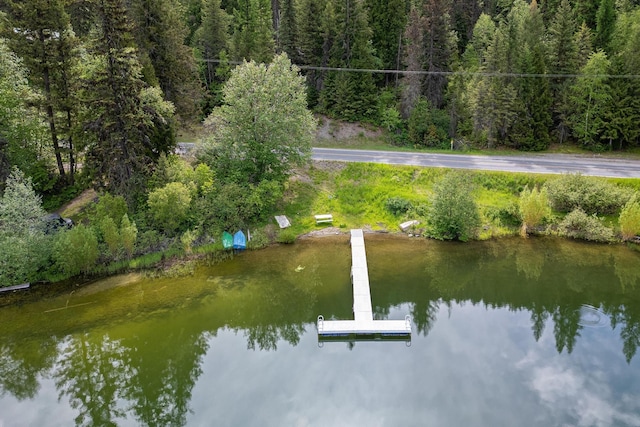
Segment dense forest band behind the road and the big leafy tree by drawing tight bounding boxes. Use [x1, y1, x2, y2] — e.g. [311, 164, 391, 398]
[0, 0, 640, 195]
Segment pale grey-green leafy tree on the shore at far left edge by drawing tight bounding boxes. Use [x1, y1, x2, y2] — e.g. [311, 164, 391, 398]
[0, 168, 49, 286]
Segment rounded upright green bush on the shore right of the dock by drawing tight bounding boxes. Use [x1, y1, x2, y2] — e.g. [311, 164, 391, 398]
[427, 172, 480, 241]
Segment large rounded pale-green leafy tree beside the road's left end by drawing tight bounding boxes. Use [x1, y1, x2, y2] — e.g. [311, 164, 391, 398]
[207, 54, 316, 184]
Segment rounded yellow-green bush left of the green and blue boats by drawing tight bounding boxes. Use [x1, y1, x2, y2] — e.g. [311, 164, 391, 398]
[147, 182, 191, 233]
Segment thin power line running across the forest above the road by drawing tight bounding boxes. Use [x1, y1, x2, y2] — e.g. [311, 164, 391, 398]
[199, 58, 640, 79]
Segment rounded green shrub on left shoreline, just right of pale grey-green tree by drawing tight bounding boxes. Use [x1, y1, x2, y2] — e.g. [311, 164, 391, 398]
[52, 224, 100, 276]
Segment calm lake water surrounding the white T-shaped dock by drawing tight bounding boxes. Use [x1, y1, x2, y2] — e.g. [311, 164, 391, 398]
[0, 234, 640, 427]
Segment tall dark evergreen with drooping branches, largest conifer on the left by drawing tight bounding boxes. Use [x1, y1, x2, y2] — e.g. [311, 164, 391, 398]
[84, 0, 174, 202]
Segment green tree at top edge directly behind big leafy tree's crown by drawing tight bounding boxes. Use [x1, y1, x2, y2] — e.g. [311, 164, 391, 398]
[231, 0, 275, 63]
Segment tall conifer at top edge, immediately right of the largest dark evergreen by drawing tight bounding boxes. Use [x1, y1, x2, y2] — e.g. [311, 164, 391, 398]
[127, 0, 201, 122]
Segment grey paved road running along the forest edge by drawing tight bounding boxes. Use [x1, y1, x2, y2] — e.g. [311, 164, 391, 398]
[312, 148, 640, 178]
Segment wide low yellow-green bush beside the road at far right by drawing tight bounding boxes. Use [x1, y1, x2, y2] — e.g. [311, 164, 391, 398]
[545, 174, 632, 215]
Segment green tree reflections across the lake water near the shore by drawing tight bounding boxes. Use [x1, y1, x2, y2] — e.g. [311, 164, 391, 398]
[0, 239, 640, 426]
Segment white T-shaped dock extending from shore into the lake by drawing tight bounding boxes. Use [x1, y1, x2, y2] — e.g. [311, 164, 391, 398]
[317, 230, 411, 336]
